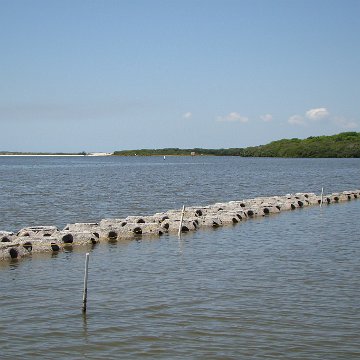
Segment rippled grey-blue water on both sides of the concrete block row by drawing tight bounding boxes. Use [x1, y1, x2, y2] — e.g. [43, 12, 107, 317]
[0, 158, 360, 359]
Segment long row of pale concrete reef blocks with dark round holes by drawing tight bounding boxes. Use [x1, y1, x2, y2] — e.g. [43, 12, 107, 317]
[0, 190, 360, 260]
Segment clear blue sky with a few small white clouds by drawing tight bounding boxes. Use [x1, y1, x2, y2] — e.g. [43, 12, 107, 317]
[0, 0, 360, 152]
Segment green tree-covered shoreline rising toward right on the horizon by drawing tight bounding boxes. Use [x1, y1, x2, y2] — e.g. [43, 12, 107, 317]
[114, 132, 360, 158]
